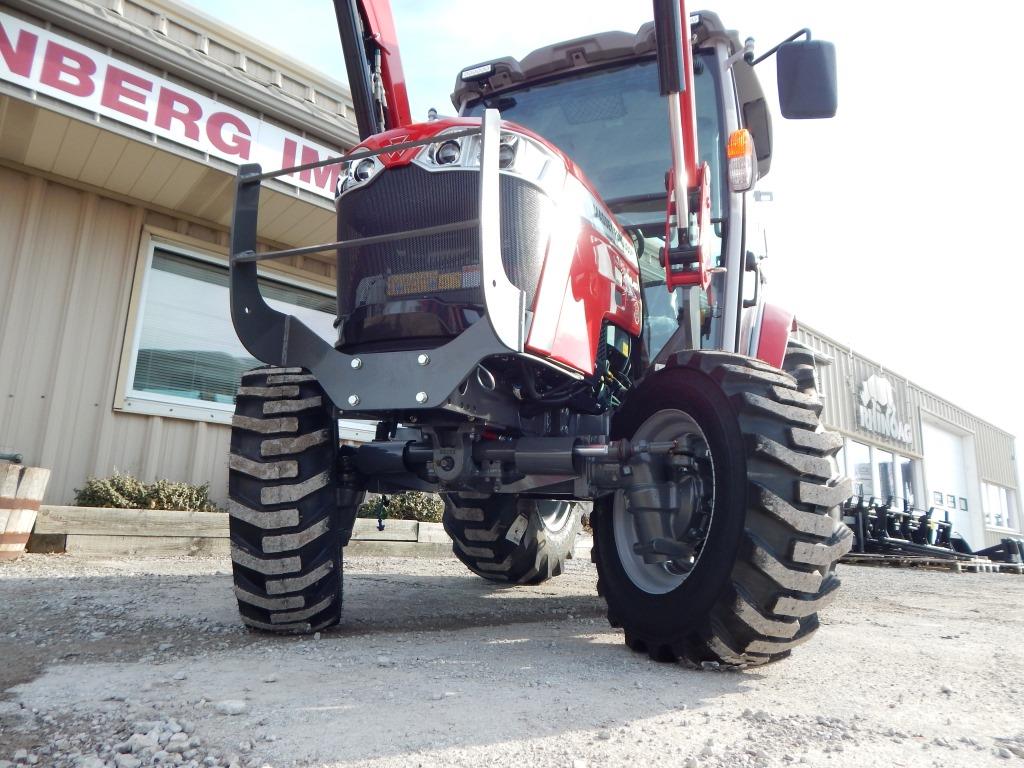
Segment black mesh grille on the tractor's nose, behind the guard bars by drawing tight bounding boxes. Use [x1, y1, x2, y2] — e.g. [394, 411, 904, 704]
[338, 165, 547, 343]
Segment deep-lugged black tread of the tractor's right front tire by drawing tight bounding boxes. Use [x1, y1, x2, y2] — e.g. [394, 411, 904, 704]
[591, 351, 852, 668]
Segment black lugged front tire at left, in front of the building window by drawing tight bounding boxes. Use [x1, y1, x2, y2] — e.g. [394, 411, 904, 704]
[228, 367, 343, 634]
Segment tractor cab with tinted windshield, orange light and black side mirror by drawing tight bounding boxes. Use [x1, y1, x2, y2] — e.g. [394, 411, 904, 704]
[452, 11, 836, 365]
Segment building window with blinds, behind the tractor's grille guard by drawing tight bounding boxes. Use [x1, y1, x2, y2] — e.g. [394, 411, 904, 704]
[124, 244, 335, 421]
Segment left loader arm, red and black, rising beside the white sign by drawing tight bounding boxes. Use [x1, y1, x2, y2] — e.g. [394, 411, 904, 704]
[334, 0, 413, 138]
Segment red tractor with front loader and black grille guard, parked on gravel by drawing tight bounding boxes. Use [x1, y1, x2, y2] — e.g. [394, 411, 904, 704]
[229, 0, 851, 667]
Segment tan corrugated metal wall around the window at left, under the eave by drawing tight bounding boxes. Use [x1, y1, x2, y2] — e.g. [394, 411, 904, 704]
[0, 166, 325, 504]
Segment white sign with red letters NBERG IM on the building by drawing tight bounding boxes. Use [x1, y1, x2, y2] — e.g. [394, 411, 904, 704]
[0, 13, 339, 199]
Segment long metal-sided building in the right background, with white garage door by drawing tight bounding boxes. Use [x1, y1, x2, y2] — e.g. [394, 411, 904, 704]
[798, 326, 1022, 549]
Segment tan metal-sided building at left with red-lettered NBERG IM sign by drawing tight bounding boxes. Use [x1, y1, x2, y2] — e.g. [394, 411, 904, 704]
[0, 0, 364, 503]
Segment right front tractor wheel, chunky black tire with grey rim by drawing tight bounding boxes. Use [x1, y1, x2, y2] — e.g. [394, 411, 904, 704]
[591, 352, 853, 667]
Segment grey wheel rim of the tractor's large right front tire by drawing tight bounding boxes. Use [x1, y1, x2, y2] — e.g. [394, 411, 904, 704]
[611, 410, 715, 595]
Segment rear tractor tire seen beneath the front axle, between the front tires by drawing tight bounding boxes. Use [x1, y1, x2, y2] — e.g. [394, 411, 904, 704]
[441, 494, 583, 584]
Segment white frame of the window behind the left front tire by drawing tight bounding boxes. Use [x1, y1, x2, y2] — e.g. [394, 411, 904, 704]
[114, 232, 331, 428]
